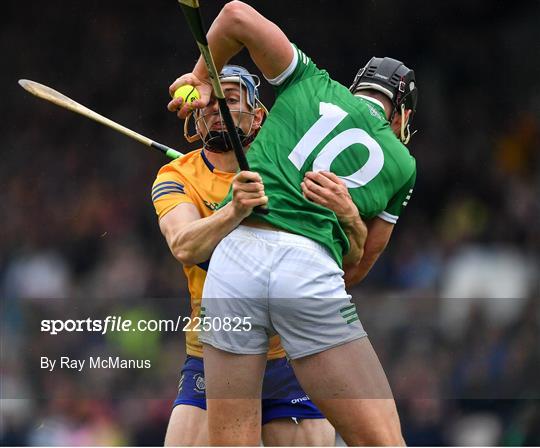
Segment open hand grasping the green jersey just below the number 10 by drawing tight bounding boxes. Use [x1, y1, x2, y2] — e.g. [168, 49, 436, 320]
[301, 171, 360, 226]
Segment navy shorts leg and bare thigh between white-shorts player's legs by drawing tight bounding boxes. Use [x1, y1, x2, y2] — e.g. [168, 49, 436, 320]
[262, 357, 336, 446]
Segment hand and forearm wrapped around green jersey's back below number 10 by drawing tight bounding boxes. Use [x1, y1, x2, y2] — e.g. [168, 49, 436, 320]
[301, 171, 367, 272]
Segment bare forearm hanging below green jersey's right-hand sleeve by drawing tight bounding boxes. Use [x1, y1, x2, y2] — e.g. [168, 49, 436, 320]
[344, 217, 394, 286]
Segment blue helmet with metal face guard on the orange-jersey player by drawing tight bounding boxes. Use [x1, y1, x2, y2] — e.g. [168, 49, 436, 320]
[184, 65, 268, 153]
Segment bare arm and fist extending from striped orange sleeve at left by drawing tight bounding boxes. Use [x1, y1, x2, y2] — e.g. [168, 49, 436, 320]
[159, 171, 268, 265]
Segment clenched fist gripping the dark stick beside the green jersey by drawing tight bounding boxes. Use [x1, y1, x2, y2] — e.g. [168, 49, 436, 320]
[232, 171, 268, 219]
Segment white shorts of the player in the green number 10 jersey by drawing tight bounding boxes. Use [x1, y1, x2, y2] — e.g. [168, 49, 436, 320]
[199, 226, 366, 359]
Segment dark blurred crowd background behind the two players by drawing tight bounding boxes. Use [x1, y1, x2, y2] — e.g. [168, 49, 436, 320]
[0, 0, 540, 445]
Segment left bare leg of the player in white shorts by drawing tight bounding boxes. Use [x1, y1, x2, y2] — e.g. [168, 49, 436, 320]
[204, 344, 266, 446]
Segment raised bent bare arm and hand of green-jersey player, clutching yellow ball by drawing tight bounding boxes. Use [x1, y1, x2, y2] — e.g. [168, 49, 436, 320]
[167, 1, 294, 118]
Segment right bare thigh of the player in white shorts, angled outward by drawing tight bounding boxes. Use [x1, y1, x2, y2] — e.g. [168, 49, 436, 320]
[292, 337, 404, 446]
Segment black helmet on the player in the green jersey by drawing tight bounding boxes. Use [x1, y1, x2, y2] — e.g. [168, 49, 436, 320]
[349, 57, 418, 114]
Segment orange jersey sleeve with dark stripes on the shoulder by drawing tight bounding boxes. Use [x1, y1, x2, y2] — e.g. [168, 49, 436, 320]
[152, 165, 194, 219]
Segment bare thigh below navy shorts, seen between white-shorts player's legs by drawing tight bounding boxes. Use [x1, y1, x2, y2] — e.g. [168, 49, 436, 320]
[262, 418, 336, 446]
